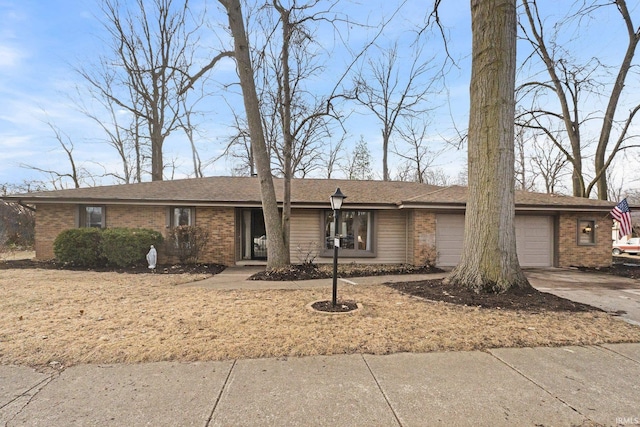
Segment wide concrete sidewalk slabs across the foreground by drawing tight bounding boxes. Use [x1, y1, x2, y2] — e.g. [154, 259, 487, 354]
[0, 344, 640, 427]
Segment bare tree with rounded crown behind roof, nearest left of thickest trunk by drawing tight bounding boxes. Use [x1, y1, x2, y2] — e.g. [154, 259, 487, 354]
[353, 43, 437, 181]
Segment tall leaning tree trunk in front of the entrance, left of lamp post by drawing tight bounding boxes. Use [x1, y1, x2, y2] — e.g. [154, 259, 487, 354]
[219, 0, 290, 269]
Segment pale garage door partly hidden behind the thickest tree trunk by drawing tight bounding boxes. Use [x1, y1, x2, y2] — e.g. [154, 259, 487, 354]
[436, 215, 553, 267]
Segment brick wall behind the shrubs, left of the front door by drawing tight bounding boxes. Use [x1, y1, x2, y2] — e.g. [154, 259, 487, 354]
[35, 204, 235, 265]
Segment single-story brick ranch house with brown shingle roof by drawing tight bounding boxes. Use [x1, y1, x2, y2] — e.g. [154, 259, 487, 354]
[4, 177, 615, 267]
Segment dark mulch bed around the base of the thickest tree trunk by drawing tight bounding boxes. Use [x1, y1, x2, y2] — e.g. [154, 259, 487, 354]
[386, 279, 602, 313]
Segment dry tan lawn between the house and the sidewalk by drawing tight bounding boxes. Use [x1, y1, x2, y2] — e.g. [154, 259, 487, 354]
[0, 269, 640, 366]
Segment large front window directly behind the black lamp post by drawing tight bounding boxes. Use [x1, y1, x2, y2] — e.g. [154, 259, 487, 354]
[323, 210, 374, 257]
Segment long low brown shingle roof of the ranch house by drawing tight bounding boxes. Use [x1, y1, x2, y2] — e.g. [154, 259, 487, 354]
[4, 177, 615, 211]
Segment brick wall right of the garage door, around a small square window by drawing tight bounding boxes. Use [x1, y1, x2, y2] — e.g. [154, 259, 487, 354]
[556, 213, 612, 267]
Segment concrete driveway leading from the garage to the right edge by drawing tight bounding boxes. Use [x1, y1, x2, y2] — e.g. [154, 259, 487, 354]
[525, 267, 640, 326]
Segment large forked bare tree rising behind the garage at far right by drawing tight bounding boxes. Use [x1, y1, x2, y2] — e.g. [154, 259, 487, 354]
[520, 0, 640, 200]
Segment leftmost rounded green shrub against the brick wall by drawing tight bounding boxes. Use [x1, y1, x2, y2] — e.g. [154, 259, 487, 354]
[53, 228, 105, 267]
